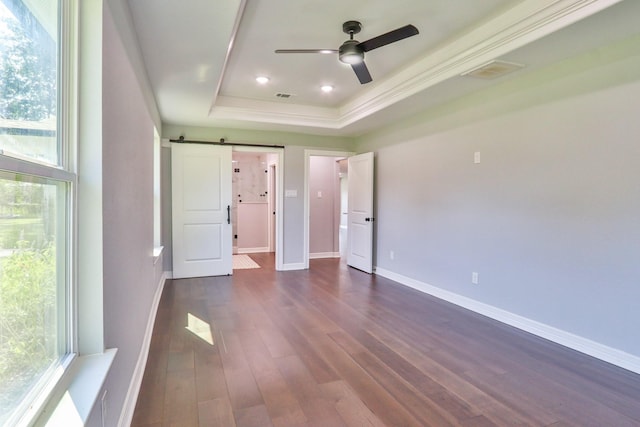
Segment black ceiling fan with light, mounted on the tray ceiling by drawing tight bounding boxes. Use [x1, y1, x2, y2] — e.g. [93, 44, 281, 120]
[275, 21, 418, 84]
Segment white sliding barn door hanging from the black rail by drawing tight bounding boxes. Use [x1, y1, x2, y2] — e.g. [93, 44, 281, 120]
[171, 144, 233, 279]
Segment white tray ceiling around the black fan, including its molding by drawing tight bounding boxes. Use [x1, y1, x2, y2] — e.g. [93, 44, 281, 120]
[128, 0, 640, 136]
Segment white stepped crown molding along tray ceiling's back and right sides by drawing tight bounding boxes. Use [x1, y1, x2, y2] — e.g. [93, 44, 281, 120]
[209, 0, 622, 129]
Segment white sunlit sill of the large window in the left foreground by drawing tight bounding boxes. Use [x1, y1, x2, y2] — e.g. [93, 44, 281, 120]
[36, 349, 118, 427]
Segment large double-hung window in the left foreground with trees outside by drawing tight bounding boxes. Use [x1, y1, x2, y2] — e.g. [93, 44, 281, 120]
[0, 0, 76, 425]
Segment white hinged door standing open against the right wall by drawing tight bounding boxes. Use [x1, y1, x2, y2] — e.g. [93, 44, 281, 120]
[347, 153, 373, 273]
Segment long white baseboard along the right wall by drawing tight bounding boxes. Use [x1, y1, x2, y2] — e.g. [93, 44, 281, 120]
[375, 268, 640, 374]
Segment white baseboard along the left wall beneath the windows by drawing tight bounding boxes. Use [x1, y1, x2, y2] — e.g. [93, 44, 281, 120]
[118, 271, 168, 427]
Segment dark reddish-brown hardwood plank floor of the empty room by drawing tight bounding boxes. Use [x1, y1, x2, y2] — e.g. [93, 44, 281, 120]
[132, 254, 640, 427]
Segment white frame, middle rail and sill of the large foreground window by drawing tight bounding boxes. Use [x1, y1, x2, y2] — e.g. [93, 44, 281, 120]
[0, 0, 117, 426]
